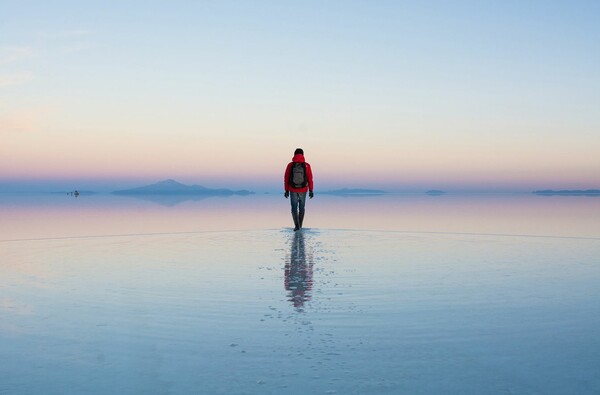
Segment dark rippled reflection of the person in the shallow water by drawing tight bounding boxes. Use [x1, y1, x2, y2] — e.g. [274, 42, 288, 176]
[284, 232, 313, 308]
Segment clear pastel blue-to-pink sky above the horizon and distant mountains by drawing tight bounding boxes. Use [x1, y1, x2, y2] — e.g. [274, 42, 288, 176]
[0, 0, 600, 191]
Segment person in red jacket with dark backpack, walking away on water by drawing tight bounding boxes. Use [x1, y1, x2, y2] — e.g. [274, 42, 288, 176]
[283, 148, 314, 231]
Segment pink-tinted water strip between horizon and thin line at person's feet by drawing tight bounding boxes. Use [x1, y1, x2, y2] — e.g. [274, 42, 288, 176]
[0, 193, 600, 240]
